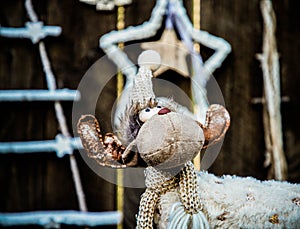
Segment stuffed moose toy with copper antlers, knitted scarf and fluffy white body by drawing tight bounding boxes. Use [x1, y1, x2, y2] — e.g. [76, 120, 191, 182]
[77, 51, 300, 229]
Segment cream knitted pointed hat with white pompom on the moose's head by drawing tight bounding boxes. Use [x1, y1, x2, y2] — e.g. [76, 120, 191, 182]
[130, 50, 161, 109]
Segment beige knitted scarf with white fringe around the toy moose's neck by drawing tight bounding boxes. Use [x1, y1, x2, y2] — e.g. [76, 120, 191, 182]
[137, 162, 208, 229]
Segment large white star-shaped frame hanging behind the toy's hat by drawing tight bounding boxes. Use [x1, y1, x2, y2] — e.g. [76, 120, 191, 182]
[100, 0, 231, 122]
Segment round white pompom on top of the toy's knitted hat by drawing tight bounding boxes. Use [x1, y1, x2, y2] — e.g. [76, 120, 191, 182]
[138, 50, 161, 71]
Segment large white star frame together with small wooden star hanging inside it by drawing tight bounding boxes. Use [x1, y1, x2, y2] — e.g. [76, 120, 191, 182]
[100, 0, 231, 126]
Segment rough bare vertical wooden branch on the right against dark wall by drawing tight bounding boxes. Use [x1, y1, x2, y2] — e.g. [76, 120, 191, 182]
[257, 0, 287, 180]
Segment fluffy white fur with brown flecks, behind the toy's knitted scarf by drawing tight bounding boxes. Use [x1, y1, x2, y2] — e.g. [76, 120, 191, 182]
[155, 172, 300, 228]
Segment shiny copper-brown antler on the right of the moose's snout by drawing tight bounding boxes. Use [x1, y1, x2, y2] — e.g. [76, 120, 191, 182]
[198, 104, 230, 149]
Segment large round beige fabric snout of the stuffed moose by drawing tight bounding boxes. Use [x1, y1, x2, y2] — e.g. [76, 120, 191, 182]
[136, 112, 204, 169]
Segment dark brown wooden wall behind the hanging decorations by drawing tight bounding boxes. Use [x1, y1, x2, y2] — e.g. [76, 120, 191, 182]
[0, 0, 300, 227]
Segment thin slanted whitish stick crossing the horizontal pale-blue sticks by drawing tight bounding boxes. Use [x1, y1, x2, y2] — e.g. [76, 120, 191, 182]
[25, 0, 87, 212]
